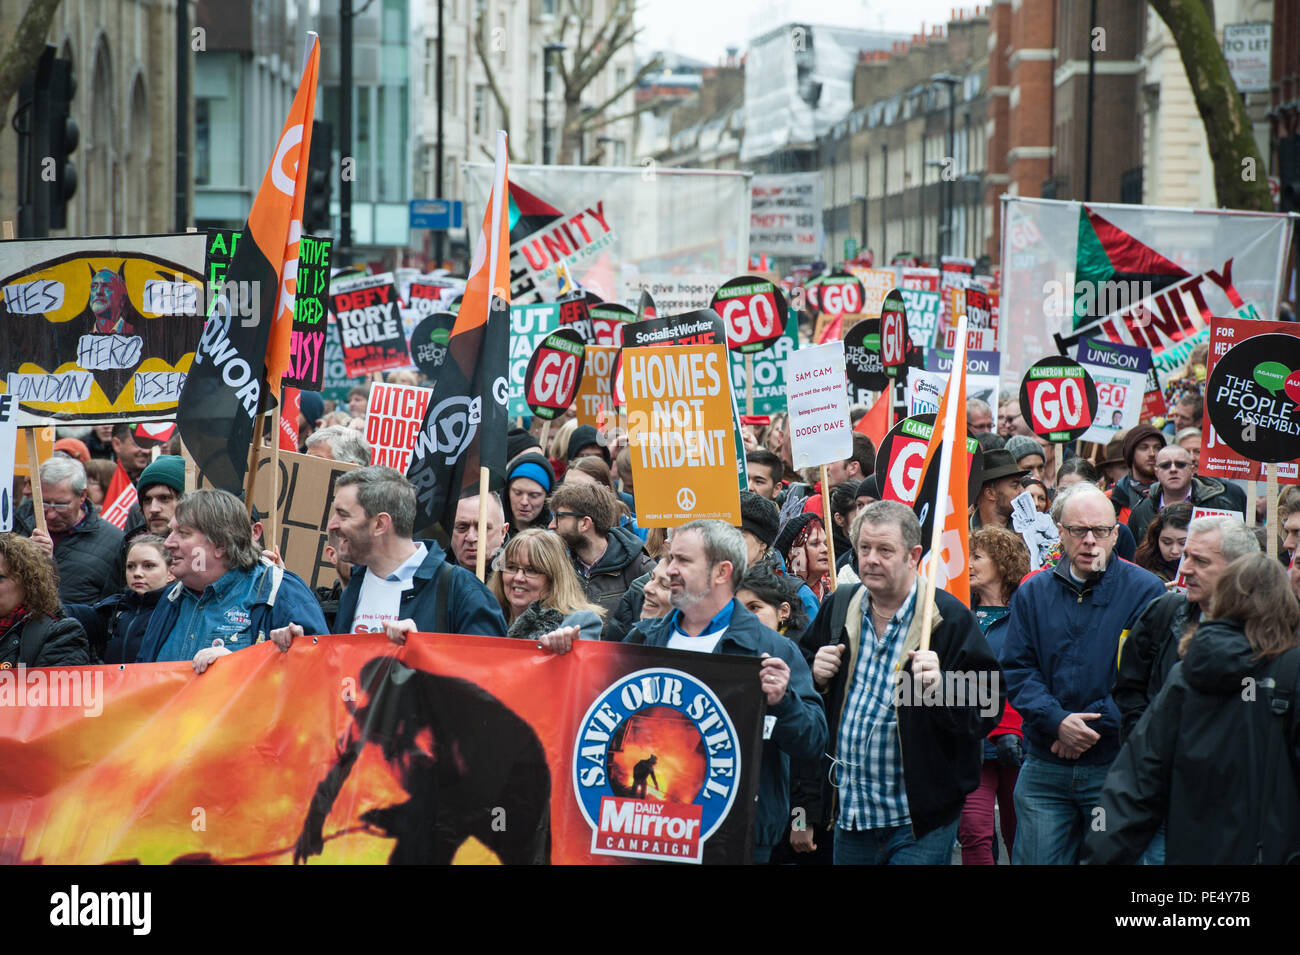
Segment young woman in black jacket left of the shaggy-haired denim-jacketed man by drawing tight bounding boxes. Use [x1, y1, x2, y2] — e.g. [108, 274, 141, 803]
[68, 533, 176, 664]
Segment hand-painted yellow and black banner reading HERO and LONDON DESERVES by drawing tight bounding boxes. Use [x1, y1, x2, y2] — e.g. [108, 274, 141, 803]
[0, 233, 205, 427]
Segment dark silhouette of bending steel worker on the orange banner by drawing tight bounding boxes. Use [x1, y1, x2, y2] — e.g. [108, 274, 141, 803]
[294, 656, 551, 865]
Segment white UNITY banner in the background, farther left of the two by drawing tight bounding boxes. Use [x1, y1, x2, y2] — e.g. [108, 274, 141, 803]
[464, 162, 749, 302]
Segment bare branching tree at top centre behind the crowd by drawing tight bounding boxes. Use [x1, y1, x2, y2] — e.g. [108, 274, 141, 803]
[475, 0, 663, 164]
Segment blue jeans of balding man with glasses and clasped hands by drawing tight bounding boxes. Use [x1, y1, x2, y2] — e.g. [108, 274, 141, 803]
[1011, 756, 1110, 865]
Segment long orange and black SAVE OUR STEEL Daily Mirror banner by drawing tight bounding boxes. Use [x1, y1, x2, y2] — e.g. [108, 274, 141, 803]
[0, 634, 763, 864]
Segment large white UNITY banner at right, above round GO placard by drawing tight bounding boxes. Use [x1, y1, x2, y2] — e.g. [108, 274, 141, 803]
[998, 196, 1292, 387]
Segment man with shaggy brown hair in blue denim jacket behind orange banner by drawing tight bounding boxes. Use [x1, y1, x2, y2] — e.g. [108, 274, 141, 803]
[137, 489, 326, 673]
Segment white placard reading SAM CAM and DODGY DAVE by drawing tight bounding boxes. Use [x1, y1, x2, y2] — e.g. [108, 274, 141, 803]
[785, 342, 853, 468]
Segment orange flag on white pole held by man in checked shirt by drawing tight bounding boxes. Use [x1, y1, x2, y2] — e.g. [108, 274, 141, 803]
[918, 316, 971, 605]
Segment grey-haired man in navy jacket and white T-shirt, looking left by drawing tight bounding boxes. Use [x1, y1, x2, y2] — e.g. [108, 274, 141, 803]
[270, 466, 506, 650]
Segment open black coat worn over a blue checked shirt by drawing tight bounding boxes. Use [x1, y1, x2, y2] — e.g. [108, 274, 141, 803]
[790, 581, 1006, 839]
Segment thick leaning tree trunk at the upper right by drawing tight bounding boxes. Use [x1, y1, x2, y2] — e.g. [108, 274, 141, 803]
[1151, 0, 1273, 212]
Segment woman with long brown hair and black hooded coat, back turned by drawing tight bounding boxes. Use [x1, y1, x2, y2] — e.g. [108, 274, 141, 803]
[1083, 554, 1300, 865]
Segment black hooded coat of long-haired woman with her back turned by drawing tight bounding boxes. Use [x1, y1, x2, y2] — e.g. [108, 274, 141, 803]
[1080, 620, 1300, 865]
